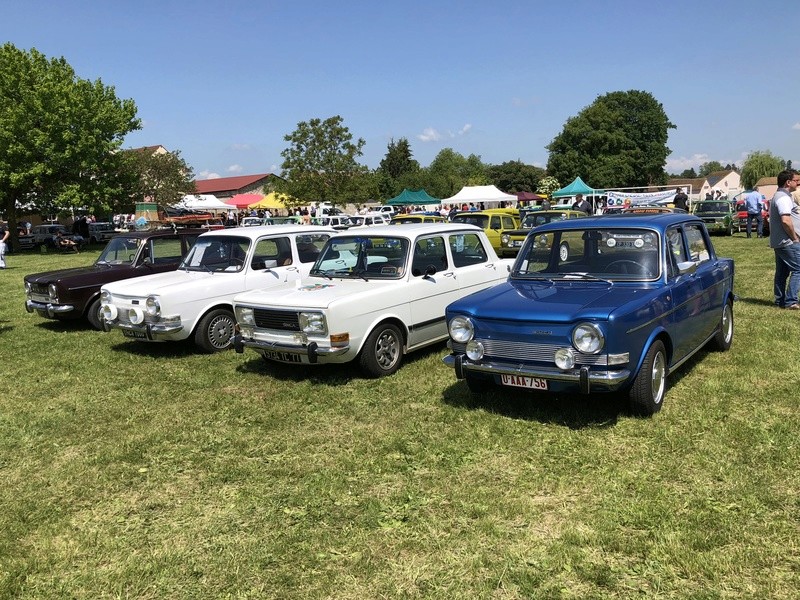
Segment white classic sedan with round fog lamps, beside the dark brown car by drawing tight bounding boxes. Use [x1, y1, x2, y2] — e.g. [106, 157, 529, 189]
[100, 225, 334, 352]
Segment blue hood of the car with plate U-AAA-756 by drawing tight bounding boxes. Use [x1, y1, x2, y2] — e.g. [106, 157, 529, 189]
[447, 281, 659, 323]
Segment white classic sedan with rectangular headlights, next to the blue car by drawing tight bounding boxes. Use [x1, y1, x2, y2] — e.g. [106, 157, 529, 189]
[233, 223, 513, 377]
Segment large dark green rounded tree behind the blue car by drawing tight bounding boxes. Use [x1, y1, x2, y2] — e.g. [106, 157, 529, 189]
[547, 90, 675, 188]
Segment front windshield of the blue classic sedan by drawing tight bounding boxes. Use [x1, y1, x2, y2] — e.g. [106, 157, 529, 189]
[511, 228, 661, 282]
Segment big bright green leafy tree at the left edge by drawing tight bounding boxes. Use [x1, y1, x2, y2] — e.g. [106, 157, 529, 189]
[0, 43, 141, 246]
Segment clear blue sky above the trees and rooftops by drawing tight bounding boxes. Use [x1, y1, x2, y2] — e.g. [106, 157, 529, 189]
[0, 0, 800, 184]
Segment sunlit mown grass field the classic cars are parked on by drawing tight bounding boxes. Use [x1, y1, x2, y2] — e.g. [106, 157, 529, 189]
[0, 234, 800, 599]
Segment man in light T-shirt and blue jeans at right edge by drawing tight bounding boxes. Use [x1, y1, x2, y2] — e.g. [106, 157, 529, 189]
[769, 169, 800, 310]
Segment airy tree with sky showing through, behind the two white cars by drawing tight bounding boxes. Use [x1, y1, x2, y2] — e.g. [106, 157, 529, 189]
[276, 115, 368, 211]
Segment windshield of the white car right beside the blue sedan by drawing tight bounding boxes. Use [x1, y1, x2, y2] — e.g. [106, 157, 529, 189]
[311, 236, 408, 279]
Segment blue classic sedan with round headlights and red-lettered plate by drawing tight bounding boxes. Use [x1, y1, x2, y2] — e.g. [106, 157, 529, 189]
[444, 214, 734, 415]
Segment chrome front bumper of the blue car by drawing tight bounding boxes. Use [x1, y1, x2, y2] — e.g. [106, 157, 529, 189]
[442, 354, 631, 394]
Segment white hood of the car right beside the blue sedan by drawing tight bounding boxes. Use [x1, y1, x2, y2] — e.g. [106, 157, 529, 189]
[233, 277, 398, 309]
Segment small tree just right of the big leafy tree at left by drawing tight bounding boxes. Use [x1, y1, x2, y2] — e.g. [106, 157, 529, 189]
[122, 148, 195, 212]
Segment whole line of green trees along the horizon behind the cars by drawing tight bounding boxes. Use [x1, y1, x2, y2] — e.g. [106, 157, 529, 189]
[0, 43, 787, 246]
